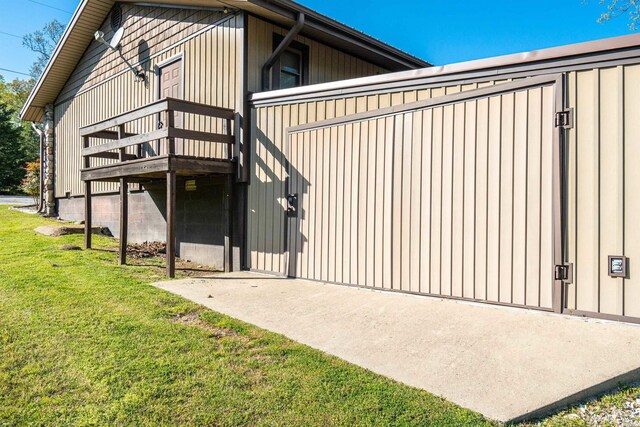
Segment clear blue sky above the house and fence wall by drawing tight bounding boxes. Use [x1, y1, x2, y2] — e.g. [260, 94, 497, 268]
[0, 0, 630, 80]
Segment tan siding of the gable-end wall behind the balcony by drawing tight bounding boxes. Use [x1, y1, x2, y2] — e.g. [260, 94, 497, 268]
[54, 5, 242, 197]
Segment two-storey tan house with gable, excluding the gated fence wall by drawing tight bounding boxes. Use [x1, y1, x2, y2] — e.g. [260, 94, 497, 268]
[23, 0, 428, 269]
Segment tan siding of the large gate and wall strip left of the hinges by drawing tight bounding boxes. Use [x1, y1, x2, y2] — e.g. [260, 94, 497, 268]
[260, 79, 554, 309]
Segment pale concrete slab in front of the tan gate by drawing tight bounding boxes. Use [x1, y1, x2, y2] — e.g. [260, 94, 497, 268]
[156, 273, 640, 421]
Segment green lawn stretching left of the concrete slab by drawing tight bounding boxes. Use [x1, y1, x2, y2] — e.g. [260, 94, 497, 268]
[0, 206, 490, 426]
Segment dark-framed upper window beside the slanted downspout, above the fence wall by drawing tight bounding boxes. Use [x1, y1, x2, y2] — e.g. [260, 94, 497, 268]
[271, 34, 309, 89]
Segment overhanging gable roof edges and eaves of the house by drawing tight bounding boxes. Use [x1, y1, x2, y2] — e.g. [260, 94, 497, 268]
[20, 0, 431, 121]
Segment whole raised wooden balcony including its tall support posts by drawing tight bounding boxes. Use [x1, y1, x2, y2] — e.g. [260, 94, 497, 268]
[80, 98, 237, 277]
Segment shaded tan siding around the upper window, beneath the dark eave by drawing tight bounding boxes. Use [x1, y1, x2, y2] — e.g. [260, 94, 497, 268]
[248, 16, 387, 92]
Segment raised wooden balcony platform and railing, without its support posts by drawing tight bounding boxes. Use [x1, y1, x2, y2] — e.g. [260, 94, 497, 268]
[80, 98, 235, 182]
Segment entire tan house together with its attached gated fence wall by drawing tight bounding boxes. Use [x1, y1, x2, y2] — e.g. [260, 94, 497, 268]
[23, 0, 640, 322]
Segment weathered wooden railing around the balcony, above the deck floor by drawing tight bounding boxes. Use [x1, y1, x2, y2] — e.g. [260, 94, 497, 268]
[80, 98, 235, 168]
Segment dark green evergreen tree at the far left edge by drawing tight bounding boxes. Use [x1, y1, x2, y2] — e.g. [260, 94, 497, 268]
[0, 101, 26, 192]
